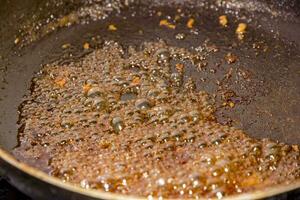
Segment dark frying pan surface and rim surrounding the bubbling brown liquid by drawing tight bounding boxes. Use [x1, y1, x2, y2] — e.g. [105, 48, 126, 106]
[0, 0, 300, 199]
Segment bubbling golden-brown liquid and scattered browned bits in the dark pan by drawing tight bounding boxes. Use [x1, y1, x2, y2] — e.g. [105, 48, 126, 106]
[14, 1, 300, 199]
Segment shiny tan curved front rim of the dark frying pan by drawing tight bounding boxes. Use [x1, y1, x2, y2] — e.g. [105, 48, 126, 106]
[0, 146, 300, 200]
